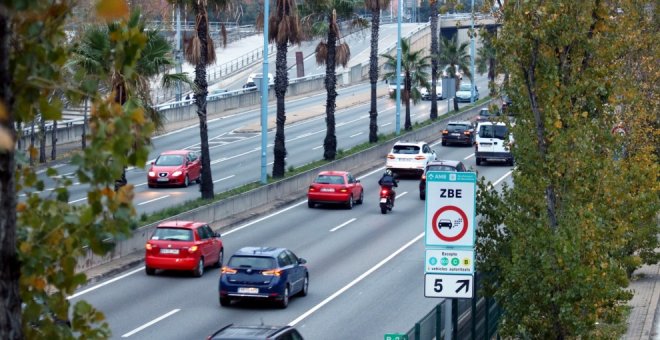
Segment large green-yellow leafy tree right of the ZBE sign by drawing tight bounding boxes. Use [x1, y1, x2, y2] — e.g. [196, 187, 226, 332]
[477, 0, 660, 339]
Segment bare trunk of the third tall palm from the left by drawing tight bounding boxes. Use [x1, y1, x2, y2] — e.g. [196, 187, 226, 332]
[323, 25, 337, 161]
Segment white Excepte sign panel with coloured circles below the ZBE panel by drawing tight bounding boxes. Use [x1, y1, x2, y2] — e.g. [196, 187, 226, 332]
[424, 248, 474, 274]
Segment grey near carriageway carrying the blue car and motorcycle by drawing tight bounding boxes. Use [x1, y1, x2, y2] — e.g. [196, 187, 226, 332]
[71, 125, 512, 339]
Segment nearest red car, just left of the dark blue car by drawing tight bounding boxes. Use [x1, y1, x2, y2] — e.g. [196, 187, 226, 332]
[144, 221, 224, 277]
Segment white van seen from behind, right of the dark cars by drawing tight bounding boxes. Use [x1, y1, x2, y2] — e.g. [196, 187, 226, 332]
[474, 122, 513, 165]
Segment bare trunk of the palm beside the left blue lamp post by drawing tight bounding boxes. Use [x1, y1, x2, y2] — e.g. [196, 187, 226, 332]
[272, 41, 289, 178]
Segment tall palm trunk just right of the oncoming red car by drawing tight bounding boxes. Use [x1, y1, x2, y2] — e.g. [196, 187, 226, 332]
[193, 1, 214, 199]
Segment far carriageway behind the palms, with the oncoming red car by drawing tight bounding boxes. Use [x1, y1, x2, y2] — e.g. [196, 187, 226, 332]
[29, 69, 488, 214]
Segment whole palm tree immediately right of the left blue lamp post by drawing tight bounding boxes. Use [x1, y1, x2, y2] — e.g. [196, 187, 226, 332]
[261, 0, 303, 178]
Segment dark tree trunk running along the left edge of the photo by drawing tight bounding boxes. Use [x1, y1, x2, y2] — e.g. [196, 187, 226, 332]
[0, 7, 23, 340]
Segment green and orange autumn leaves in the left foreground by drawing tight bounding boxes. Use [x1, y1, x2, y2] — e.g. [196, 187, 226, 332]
[0, 0, 153, 339]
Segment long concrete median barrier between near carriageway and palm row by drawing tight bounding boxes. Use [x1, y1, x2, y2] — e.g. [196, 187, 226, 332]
[76, 102, 490, 271]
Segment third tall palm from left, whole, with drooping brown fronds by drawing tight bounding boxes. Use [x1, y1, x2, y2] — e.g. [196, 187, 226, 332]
[301, 0, 357, 160]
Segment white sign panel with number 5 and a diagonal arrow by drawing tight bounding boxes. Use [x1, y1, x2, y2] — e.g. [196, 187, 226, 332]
[424, 274, 474, 299]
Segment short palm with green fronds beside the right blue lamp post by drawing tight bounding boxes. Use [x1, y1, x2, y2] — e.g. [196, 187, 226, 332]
[381, 39, 431, 130]
